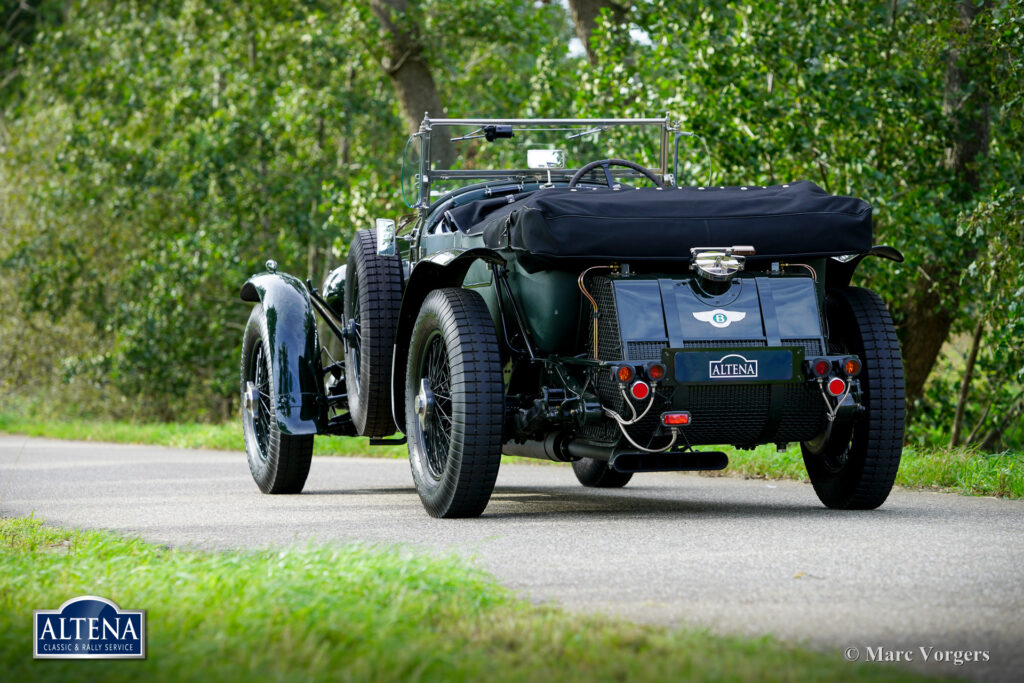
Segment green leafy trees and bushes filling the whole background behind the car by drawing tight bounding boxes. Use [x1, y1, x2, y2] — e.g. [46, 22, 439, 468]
[0, 0, 1024, 449]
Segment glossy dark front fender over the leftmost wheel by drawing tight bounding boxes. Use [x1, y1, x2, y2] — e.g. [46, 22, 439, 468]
[241, 272, 327, 434]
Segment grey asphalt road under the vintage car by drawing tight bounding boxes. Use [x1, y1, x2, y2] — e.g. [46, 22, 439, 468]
[0, 436, 1024, 681]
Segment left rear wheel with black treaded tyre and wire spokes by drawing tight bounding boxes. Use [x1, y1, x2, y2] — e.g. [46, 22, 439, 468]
[406, 289, 505, 517]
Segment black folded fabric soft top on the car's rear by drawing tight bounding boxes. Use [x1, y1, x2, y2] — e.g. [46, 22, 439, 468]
[450, 180, 871, 265]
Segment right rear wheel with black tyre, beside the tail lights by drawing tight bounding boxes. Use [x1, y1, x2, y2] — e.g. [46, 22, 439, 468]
[801, 287, 906, 510]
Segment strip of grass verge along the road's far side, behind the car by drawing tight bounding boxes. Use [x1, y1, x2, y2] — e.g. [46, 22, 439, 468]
[0, 413, 1024, 498]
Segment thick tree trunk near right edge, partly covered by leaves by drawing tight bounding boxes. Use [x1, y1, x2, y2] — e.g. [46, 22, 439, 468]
[900, 0, 991, 404]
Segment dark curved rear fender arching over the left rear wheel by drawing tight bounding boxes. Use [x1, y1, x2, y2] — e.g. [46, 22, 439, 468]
[391, 248, 505, 432]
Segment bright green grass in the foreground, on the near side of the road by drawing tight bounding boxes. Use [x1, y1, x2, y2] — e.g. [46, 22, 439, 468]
[0, 518, 929, 681]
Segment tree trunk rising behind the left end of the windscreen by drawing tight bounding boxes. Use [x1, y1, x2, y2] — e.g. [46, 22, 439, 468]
[370, 0, 455, 168]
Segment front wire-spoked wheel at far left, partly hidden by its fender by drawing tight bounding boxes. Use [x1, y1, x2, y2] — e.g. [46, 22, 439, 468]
[242, 304, 313, 494]
